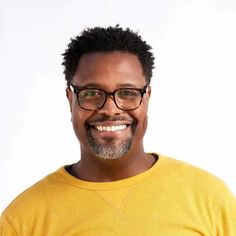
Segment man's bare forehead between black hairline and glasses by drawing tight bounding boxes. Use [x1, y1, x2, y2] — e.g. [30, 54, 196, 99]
[73, 52, 145, 87]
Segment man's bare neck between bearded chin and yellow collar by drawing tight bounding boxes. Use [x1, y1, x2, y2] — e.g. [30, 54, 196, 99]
[71, 149, 155, 182]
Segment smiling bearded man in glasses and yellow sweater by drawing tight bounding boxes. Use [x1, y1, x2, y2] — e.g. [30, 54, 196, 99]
[0, 26, 236, 236]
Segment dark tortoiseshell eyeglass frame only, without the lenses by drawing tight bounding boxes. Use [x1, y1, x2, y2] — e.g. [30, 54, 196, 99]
[68, 83, 149, 111]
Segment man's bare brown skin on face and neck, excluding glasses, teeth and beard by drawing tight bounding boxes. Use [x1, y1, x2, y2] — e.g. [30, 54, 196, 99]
[66, 52, 155, 182]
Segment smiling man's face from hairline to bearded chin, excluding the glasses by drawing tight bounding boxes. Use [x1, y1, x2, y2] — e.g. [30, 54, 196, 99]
[67, 52, 150, 159]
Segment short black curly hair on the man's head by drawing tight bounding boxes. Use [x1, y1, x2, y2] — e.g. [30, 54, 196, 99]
[62, 25, 154, 86]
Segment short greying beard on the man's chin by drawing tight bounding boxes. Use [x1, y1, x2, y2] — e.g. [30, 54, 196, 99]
[87, 129, 133, 160]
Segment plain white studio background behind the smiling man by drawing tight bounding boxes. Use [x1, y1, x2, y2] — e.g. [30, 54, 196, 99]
[0, 0, 236, 212]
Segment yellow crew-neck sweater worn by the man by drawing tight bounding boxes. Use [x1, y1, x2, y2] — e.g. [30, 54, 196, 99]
[0, 156, 236, 236]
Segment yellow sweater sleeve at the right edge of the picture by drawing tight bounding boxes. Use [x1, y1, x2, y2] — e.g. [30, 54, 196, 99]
[216, 186, 236, 236]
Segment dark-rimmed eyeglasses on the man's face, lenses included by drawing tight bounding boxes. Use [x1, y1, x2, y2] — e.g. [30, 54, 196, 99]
[69, 84, 148, 111]
